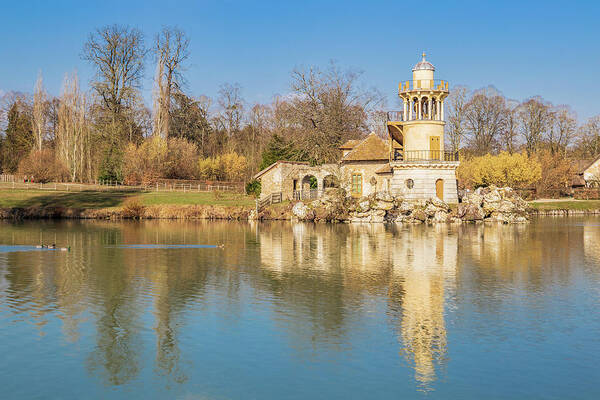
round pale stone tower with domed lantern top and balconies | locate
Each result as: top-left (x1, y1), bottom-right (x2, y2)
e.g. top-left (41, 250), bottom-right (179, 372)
top-left (387, 53), bottom-right (458, 203)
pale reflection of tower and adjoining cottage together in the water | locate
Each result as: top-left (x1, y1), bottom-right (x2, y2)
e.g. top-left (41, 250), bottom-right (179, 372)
top-left (259, 224), bottom-right (458, 388)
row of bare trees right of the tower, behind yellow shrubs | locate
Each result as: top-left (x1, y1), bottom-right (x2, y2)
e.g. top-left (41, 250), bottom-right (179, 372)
top-left (446, 86), bottom-right (600, 159)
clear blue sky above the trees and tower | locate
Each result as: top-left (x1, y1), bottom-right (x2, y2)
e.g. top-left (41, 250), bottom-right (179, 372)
top-left (0, 0), bottom-right (600, 120)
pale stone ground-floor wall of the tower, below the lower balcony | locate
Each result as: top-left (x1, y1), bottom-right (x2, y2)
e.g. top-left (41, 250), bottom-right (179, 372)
top-left (391, 164), bottom-right (458, 204)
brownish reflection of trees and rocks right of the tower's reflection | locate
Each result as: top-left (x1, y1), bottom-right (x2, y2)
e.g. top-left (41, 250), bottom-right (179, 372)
top-left (460, 219), bottom-right (582, 311)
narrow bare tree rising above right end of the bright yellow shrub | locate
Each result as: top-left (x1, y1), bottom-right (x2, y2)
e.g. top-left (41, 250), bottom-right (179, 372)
top-left (519, 97), bottom-right (550, 155)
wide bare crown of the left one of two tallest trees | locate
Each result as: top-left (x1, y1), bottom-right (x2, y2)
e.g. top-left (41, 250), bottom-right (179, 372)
top-left (82, 25), bottom-right (147, 114)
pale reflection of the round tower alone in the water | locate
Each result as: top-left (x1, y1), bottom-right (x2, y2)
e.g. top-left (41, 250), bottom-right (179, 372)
top-left (392, 226), bottom-right (458, 385)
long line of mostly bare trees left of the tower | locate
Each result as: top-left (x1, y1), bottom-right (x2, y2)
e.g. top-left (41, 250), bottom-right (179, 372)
top-left (0, 25), bottom-right (382, 182)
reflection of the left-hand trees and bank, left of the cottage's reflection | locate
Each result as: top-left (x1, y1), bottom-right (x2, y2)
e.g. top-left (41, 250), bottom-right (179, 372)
top-left (0, 221), bottom-right (253, 385)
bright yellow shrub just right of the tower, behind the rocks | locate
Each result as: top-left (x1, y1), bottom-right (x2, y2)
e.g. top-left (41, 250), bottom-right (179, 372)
top-left (457, 152), bottom-right (542, 188)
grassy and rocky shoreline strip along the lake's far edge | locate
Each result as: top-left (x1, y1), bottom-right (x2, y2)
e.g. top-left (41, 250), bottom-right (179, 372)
top-left (0, 187), bottom-right (600, 223)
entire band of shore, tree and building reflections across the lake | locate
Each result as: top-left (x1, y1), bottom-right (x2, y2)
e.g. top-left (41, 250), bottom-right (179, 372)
top-left (0, 221), bottom-right (600, 396)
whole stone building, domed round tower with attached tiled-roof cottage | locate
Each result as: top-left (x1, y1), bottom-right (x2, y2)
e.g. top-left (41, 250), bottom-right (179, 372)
top-left (254, 53), bottom-right (459, 203)
